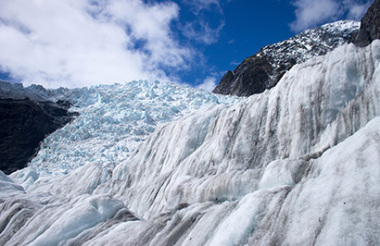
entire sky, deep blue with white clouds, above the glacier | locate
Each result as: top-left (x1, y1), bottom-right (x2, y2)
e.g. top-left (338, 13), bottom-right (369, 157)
top-left (0, 0), bottom-right (373, 90)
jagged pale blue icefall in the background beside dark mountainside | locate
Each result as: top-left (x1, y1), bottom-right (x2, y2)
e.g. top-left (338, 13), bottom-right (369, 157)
top-left (13, 80), bottom-right (241, 187)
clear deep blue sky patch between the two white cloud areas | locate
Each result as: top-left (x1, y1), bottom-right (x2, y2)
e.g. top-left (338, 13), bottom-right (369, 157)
top-left (174, 0), bottom-right (297, 89)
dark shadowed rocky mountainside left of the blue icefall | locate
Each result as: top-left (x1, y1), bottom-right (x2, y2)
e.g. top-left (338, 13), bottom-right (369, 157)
top-left (0, 82), bottom-right (76, 174)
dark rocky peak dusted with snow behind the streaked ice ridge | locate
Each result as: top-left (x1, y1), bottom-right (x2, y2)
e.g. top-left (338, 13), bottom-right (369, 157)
top-left (213, 21), bottom-right (360, 96)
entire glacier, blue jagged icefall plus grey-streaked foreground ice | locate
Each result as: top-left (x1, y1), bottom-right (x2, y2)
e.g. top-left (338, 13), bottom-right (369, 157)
top-left (0, 40), bottom-right (380, 245)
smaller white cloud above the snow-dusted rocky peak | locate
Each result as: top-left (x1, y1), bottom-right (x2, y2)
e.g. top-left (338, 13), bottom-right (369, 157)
top-left (290, 0), bottom-right (373, 32)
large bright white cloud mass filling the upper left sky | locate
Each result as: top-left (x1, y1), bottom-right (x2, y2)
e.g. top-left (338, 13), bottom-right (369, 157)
top-left (0, 0), bottom-right (191, 88)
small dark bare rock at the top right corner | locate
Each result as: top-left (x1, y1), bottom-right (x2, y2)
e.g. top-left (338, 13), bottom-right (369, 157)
top-left (354, 0), bottom-right (380, 47)
